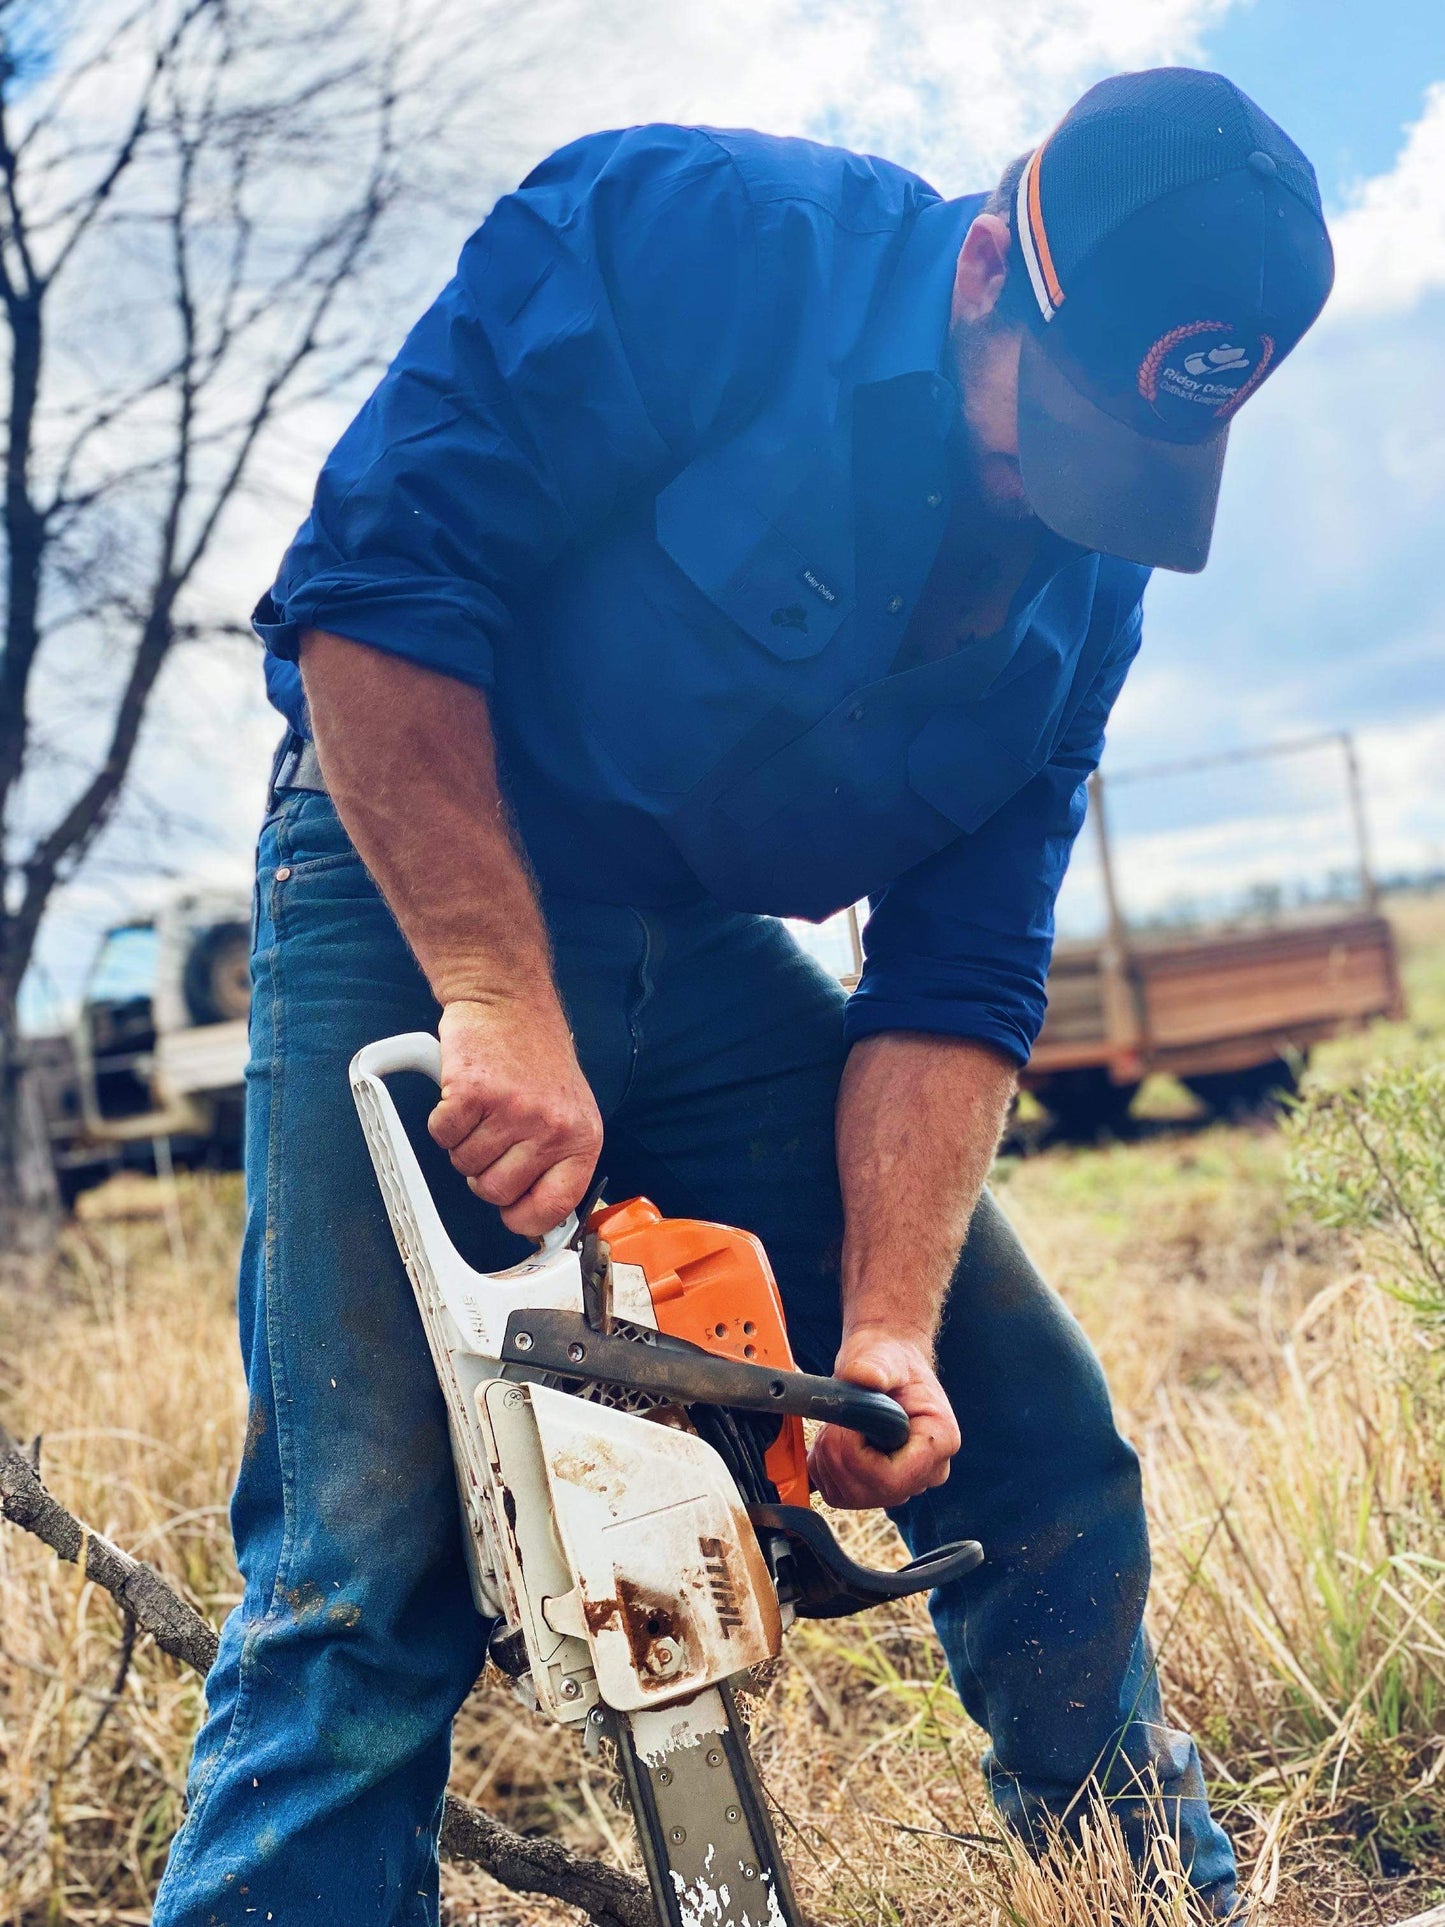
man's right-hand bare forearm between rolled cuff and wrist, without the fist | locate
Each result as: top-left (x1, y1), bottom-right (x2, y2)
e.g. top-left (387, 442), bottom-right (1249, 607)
top-left (838, 1031), bottom-right (1015, 1347)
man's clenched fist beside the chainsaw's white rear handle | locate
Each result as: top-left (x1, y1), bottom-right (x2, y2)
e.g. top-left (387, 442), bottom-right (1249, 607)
top-left (428, 998), bottom-right (603, 1237)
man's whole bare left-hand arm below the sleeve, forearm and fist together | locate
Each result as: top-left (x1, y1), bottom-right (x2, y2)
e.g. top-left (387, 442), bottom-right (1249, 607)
top-left (301, 630), bottom-right (603, 1237)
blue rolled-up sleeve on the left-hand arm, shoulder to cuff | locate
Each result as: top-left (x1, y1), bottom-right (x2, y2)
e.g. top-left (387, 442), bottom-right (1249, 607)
top-left (254, 127), bottom-right (763, 686)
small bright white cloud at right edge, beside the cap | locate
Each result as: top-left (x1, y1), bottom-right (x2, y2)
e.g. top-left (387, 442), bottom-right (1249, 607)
top-left (1326, 81), bottom-right (1445, 320)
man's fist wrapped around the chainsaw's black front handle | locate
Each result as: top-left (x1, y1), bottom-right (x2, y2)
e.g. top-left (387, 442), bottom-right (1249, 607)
top-left (807, 1326), bottom-right (963, 1507)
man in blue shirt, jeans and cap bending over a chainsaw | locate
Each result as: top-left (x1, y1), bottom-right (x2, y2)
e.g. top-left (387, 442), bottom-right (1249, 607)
top-left (156, 69), bottom-right (1331, 1927)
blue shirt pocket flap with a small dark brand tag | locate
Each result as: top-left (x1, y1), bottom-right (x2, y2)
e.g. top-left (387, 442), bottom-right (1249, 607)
top-left (657, 459), bottom-right (854, 661)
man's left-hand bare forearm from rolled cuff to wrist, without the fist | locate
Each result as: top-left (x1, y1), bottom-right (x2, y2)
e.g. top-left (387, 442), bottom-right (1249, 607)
top-left (301, 630), bottom-right (551, 1004)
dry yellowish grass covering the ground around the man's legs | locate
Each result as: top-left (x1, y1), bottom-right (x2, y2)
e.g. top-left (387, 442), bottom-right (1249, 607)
top-left (0, 906), bottom-right (1445, 1927)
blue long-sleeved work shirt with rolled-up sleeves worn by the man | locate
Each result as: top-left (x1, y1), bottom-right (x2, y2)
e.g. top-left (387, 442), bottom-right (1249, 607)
top-left (256, 125), bottom-right (1146, 1062)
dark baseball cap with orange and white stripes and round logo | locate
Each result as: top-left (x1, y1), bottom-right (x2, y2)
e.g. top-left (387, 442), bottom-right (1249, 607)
top-left (1013, 67), bottom-right (1333, 572)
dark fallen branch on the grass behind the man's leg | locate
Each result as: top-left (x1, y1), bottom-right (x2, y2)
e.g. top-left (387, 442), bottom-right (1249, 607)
top-left (0, 1426), bottom-right (657, 1927)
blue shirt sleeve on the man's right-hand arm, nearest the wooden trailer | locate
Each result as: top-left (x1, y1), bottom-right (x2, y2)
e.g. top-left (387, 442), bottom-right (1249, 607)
top-left (844, 605), bottom-right (1141, 1066)
